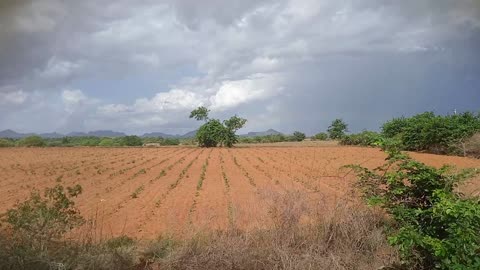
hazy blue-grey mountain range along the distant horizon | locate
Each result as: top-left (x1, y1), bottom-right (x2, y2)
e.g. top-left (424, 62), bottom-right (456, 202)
top-left (0, 129), bottom-right (282, 139)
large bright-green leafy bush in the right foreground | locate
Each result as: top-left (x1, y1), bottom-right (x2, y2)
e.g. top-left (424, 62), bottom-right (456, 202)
top-left (349, 150), bottom-right (480, 269)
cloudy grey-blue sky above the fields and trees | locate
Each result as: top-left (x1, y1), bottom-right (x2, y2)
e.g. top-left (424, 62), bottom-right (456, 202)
top-left (0, 0), bottom-right (480, 134)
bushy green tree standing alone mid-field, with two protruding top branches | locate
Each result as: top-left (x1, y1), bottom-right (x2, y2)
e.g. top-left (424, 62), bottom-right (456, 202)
top-left (190, 107), bottom-right (247, 147)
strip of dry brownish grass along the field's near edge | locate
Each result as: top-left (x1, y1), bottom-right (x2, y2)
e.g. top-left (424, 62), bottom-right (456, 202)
top-left (0, 191), bottom-right (398, 270)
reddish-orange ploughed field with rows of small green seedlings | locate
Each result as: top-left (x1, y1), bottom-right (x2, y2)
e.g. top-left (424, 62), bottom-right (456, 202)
top-left (0, 146), bottom-right (480, 238)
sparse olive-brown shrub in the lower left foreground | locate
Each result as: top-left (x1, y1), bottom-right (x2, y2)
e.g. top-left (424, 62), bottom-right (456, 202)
top-left (0, 185), bottom-right (84, 268)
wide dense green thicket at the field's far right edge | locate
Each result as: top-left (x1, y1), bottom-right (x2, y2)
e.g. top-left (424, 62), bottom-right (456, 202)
top-left (382, 112), bottom-right (480, 154)
